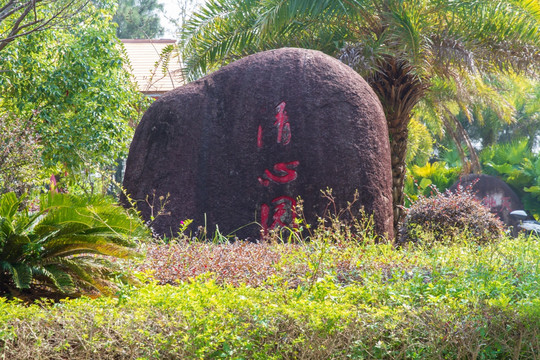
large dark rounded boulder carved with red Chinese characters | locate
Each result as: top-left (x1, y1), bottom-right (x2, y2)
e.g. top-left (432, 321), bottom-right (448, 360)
top-left (124, 48), bottom-right (393, 239)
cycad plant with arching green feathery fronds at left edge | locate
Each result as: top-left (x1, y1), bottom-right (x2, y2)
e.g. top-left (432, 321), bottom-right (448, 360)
top-left (0, 192), bottom-right (145, 298)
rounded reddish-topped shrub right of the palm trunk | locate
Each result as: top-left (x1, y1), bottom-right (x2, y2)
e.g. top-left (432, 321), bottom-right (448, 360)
top-left (398, 188), bottom-right (503, 243)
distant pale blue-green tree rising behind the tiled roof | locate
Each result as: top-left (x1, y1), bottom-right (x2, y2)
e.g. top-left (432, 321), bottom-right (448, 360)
top-left (113, 0), bottom-right (163, 39)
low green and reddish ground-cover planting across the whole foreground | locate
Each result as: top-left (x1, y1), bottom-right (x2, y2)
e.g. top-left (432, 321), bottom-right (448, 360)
top-left (0, 232), bottom-right (540, 359)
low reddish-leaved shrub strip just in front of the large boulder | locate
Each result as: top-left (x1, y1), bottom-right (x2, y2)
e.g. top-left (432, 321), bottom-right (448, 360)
top-left (135, 241), bottom-right (404, 288)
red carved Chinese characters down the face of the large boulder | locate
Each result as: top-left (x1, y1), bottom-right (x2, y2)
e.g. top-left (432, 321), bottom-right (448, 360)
top-left (257, 101), bottom-right (300, 234)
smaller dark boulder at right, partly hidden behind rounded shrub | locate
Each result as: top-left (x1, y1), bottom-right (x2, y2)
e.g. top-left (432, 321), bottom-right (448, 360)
top-left (450, 174), bottom-right (523, 235)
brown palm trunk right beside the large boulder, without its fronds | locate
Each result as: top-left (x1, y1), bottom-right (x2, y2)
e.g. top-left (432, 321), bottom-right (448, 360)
top-left (366, 57), bottom-right (427, 238)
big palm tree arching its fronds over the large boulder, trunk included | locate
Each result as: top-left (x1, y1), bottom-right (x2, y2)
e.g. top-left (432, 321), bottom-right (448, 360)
top-left (182, 0), bottom-right (540, 234)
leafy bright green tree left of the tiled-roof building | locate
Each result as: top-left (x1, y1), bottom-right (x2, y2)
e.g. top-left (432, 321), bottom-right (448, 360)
top-left (0, 0), bottom-right (146, 194)
